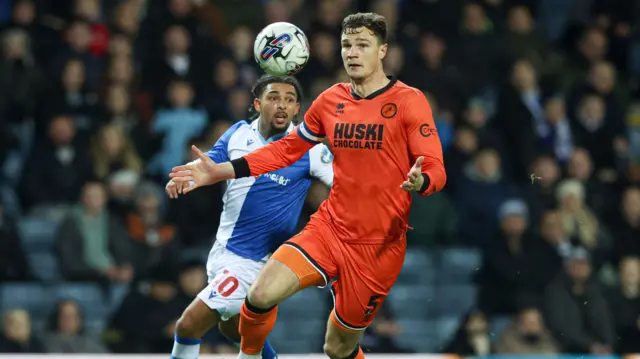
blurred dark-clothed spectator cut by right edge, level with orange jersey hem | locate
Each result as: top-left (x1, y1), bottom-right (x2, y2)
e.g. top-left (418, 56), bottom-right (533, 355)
top-left (607, 187), bottom-right (640, 265)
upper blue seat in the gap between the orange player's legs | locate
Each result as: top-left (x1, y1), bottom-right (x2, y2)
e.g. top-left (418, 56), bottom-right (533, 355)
top-left (278, 288), bottom-right (331, 318)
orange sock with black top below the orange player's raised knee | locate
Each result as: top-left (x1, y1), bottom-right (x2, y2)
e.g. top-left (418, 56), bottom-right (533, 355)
top-left (239, 300), bottom-right (278, 358)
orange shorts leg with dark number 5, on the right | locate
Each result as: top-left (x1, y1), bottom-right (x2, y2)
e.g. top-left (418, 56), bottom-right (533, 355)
top-left (331, 241), bottom-right (406, 331)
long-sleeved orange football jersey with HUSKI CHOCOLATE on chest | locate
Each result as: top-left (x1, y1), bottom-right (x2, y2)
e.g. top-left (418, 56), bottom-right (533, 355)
top-left (239, 78), bottom-right (446, 243)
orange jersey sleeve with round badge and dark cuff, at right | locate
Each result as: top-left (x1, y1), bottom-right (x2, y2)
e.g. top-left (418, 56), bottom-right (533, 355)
top-left (403, 93), bottom-right (447, 196)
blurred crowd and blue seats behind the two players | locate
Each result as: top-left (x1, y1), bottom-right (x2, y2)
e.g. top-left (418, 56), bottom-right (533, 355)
top-left (0, 0), bottom-right (640, 355)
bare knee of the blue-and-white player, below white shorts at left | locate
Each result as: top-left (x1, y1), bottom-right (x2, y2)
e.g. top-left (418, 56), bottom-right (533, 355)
top-left (176, 298), bottom-right (220, 338)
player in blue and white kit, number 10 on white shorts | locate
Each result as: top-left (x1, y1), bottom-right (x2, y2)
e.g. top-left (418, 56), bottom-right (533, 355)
top-left (166, 76), bottom-right (333, 359)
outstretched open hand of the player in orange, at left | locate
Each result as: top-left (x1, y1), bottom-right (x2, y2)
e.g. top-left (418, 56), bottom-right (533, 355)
top-left (169, 146), bottom-right (226, 194)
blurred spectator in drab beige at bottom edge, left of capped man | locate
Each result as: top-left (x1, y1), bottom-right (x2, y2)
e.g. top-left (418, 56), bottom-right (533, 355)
top-left (496, 308), bottom-right (560, 355)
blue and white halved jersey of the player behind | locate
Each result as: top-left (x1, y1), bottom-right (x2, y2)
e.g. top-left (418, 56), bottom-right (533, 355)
top-left (207, 119), bottom-right (333, 261)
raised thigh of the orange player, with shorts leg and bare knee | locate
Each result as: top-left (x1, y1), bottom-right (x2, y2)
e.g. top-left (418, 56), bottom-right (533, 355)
top-left (249, 222), bottom-right (336, 308)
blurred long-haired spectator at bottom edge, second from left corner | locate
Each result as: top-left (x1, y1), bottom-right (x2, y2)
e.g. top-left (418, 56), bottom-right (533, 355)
top-left (42, 300), bottom-right (107, 354)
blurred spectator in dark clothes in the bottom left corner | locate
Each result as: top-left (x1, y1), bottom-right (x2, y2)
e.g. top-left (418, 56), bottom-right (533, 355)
top-left (0, 309), bottom-right (45, 353)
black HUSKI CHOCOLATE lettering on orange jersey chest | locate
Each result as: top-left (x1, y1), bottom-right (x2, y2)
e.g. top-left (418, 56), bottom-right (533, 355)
top-left (332, 122), bottom-right (384, 150)
